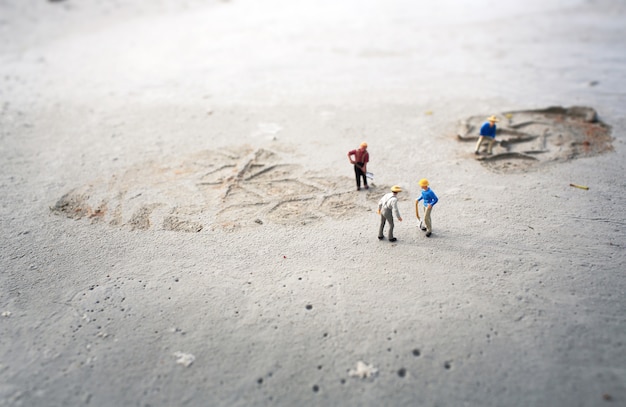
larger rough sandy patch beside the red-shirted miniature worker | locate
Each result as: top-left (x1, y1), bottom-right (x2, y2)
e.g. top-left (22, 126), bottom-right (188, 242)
top-left (52, 146), bottom-right (386, 232)
